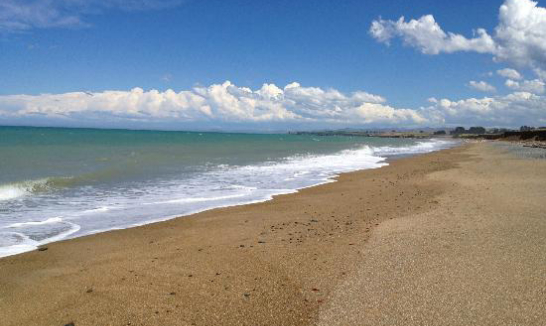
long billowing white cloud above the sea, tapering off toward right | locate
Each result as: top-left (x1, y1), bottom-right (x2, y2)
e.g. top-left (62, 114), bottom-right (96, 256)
top-left (0, 81), bottom-right (427, 128)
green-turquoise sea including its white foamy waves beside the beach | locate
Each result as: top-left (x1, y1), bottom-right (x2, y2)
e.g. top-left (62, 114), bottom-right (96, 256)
top-left (0, 127), bottom-right (454, 257)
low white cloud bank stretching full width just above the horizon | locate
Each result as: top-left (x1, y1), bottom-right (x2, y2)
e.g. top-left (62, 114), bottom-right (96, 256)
top-left (0, 81), bottom-right (546, 129)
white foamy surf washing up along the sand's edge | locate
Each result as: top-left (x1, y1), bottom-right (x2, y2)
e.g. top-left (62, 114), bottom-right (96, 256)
top-left (0, 140), bottom-right (453, 257)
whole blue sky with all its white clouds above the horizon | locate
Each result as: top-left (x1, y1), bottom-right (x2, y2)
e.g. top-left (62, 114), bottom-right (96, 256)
top-left (0, 0), bottom-right (546, 132)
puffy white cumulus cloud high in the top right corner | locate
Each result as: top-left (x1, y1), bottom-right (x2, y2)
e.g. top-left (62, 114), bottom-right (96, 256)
top-left (370, 0), bottom-right (546, 74)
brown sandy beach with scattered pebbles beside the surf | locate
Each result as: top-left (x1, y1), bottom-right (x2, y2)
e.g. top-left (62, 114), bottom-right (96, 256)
top-left (0, 143), bottom-right (546, 326)
